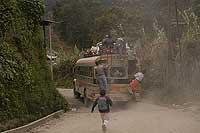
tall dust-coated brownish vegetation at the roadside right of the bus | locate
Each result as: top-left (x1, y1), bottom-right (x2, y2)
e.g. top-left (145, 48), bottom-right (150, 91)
top-left (141, 0), bottom-right (200, 104)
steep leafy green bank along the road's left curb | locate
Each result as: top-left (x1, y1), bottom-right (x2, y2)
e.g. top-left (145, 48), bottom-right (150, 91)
top-left (0, 0), bottom-right (66, 131)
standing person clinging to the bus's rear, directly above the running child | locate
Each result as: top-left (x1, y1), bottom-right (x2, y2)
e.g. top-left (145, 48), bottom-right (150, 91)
top-left (95, 62), bottom-right (108, 90)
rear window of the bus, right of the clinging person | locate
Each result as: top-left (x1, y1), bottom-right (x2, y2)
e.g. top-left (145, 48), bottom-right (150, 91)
top-left (110, 67), bottom-right (126, 77)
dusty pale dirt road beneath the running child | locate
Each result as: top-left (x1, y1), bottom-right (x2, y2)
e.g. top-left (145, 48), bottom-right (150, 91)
top-left (31, 90), bottom-right (200, 133)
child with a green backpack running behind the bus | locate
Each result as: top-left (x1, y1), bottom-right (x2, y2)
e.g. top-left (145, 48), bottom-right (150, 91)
top-left (91, 90), bottom-right (112, 130)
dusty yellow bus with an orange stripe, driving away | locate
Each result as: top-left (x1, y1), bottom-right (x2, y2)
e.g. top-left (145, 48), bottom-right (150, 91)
top-left (73, 54), bottom-right (131, 106)
